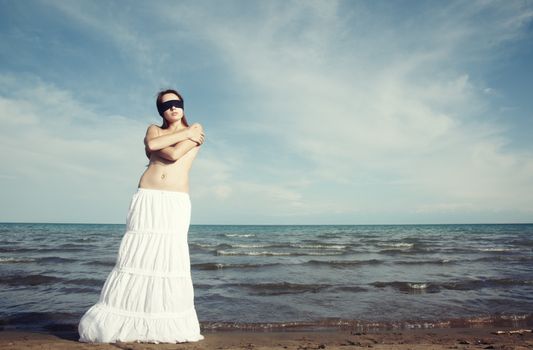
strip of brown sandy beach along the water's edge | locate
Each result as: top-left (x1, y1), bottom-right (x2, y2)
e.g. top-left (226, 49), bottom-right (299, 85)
top-left (0, 328), bottom-right (533, 350)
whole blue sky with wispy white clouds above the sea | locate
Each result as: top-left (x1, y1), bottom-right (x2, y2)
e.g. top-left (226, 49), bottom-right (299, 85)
top-left (0, 0), bottom-right (533, 224)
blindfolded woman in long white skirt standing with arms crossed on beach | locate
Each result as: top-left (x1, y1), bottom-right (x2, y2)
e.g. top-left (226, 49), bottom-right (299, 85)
top-left (78, 90), bottom-right (204, 343)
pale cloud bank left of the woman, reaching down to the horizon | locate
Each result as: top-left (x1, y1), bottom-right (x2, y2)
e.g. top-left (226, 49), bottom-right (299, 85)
top-left (0, 74), bottom-right (145, 222)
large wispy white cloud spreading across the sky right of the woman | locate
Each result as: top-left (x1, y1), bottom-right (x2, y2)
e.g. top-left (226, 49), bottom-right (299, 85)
top-left (160, 2), bottom-right (533, 217)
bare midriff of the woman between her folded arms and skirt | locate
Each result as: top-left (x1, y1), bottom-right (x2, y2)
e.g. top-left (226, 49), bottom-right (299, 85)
top-left (138, 129), bottom-right (200, 193)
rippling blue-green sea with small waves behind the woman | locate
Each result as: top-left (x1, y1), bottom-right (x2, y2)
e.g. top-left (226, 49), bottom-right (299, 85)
top-left (0, 223), bottom-right (533, 332)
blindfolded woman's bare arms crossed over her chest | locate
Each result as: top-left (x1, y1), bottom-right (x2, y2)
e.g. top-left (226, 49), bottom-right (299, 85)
top-left (144, 124), bottom-right (204, 161)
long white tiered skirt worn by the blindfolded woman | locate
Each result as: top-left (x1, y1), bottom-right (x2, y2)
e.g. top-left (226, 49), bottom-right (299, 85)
top-left (78, 188), bottom-right (204, 343)
